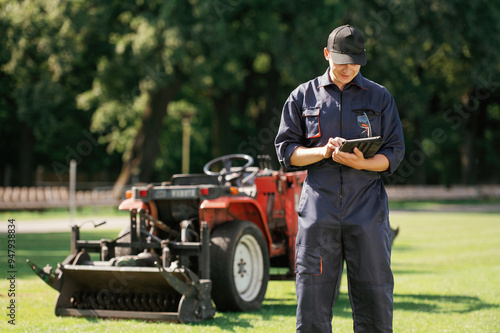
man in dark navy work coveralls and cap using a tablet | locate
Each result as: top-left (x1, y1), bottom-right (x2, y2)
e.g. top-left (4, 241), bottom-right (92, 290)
top-left (275, 25), bottom-right (404, 333)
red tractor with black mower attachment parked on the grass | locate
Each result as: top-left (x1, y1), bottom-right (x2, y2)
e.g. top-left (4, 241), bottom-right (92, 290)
top-left (28, 154), bottom-right (306, 322)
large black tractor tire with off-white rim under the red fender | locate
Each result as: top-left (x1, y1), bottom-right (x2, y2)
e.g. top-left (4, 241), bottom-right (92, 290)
top-left (210, 221), bottom-right (269, 311)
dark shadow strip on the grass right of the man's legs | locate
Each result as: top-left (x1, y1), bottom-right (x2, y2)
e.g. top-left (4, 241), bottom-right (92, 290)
top-left (394, 294), bottom-right (500, 314)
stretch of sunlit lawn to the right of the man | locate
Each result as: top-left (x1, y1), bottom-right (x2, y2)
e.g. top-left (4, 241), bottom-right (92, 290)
top-left (392, 213), bottom-right (500, 333)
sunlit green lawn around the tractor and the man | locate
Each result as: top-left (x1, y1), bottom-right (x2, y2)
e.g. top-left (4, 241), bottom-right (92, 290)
top-left (0, 208), bottom-right (500, 333)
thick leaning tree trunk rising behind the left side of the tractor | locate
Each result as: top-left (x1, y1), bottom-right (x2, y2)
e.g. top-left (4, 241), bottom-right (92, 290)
top-left (113, 84), bottom-right (180, 197)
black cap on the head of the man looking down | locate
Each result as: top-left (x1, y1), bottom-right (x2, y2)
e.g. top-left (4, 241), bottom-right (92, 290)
top-left (327, 24), bottom-right (366, 65)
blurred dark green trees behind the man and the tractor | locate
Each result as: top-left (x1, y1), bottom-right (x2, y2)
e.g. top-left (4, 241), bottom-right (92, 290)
top-left (0, 0), bottom-right (500, 204)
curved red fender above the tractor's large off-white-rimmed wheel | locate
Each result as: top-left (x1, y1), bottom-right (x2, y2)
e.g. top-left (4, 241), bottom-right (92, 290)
top-left (200, 196), bottom-right (272, 249)
